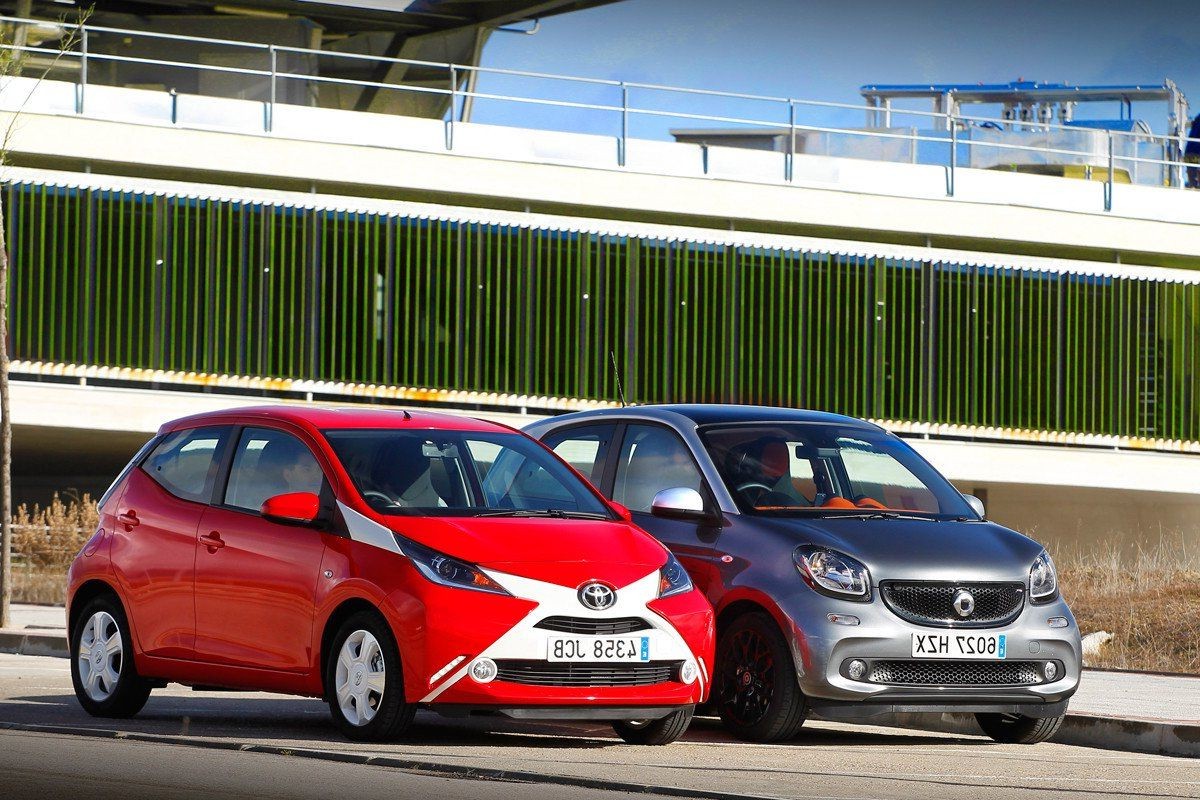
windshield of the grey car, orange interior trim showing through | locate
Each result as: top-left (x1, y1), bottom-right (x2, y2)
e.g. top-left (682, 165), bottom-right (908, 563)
top-left (700, 422), bottom-right (976, 519)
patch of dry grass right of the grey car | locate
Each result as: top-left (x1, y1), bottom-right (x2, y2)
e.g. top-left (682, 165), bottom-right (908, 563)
top-left (1054, 537), bottom-right (1200, 674)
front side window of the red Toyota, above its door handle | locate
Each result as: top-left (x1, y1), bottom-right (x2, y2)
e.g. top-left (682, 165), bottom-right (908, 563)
top-left (224, 428), bottom-right (325, 513)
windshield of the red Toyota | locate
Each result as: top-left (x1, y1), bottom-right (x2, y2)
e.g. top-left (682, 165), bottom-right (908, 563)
top-left (324, 429), bottom-right (613, 519)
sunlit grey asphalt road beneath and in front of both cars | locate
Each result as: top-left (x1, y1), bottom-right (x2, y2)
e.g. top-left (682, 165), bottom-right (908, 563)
top-left (0, 655), bottom-right (1200, 800)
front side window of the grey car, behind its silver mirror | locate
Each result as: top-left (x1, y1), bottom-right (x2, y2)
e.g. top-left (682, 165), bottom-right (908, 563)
top-left (612, 425), bottom-right (701, 513)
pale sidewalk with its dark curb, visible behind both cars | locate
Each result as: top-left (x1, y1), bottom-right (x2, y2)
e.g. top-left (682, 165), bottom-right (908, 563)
top-left (7, 604), bottom-right (1200, 757)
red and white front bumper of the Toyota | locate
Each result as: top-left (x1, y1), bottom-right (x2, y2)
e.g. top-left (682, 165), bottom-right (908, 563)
top-left (390, 563), bottom-right (714, 720)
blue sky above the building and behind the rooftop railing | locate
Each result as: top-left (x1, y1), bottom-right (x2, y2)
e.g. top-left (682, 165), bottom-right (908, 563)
top-left (474, 0), bottom-right (1200, 138)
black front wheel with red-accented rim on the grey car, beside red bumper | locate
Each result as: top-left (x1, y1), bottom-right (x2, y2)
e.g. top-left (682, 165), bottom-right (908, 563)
top-left (714, 612), bottom-right (808, 742)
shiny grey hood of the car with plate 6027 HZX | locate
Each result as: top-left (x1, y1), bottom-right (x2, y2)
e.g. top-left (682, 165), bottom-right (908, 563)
top-left (761, 517), bottom-right (1043, 585)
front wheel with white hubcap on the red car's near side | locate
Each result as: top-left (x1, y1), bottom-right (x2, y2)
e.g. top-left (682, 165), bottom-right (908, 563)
top-left (325, 612), bottom-right (416, 741)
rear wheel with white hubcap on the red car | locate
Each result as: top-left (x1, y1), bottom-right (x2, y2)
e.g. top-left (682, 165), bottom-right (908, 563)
top-left (71, 595), bottom-right (150, 718)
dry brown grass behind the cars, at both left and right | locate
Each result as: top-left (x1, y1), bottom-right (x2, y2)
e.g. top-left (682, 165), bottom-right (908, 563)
top-left (4, 495), bottom-right (1200, 673)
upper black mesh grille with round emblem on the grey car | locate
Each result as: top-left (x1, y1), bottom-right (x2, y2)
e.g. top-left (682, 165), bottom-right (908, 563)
top-left (881, 581), bottom-right (1025, 627)
